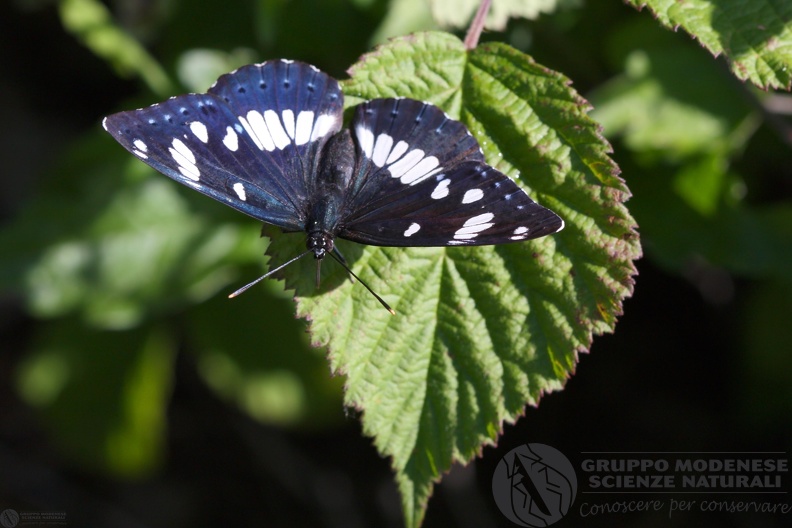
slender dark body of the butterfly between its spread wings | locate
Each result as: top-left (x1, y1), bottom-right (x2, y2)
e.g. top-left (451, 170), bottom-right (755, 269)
top-left (305, 130), bottom-right (355, 259)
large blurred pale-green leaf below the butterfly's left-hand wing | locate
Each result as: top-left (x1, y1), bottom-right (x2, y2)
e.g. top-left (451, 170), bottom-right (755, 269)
top-left (0, 130), bottom-right (261, 329)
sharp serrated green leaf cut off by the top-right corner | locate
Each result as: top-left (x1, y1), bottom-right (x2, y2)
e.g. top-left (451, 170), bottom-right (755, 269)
top-left (628, 0), bottom-right (792, 90)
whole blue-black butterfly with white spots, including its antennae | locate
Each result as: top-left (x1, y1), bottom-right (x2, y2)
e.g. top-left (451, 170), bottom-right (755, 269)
top-left (102, 59), bottom-right (564, 313)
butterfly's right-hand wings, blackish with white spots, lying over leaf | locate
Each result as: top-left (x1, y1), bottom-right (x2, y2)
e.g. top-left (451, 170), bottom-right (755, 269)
top-left (338, 99), bottom-right (564, 246)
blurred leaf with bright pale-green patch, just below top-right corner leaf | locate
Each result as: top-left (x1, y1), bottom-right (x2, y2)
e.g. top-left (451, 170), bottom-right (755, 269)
top-left (591, 19), bottom-right (757, 161)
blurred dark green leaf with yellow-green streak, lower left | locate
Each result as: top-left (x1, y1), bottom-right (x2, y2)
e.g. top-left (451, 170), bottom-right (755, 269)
top-left (17, 319), bottom-right (174, 477)
